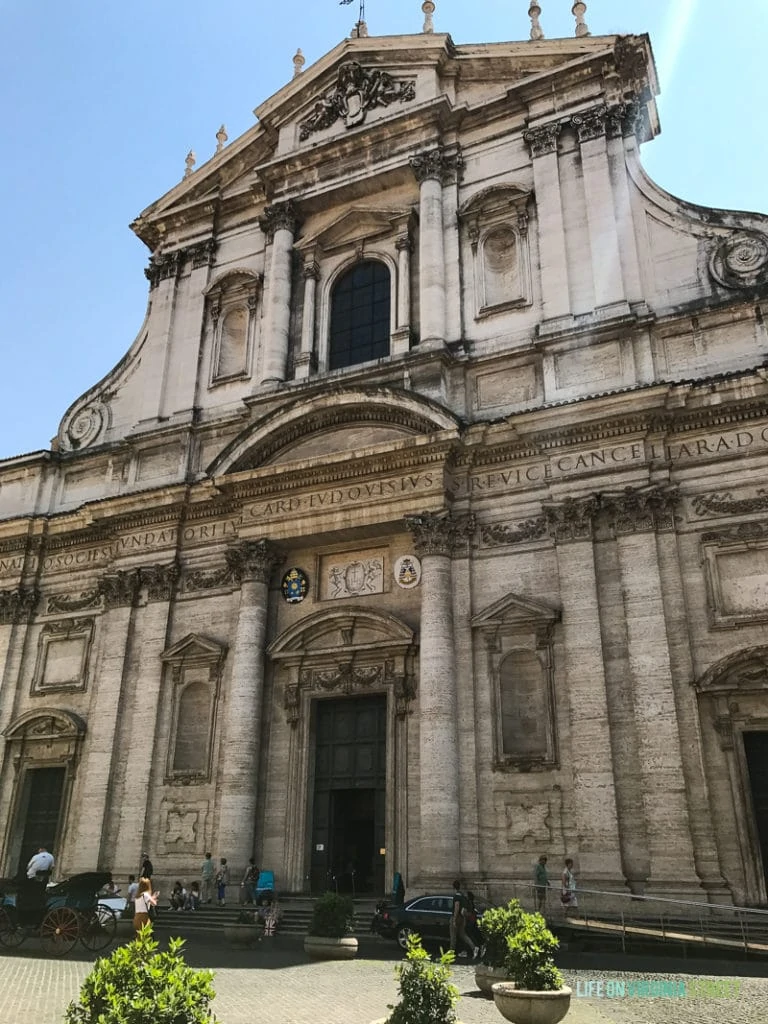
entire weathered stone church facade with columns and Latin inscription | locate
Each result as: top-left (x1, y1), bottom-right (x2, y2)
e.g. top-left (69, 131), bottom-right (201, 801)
top-left (0, 16), bottom-right (768, 903)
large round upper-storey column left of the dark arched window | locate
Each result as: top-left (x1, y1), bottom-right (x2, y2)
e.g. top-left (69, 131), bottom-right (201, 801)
top-left (260, 202), bottom-right (297, 384)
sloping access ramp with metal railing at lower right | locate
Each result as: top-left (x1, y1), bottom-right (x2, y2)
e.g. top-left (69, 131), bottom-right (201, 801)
top-left (510, 882), bottom-right (768, 955)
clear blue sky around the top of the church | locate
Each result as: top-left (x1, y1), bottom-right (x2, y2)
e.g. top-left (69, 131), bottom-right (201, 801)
top-left (0, 0), bottom-right (768, 458)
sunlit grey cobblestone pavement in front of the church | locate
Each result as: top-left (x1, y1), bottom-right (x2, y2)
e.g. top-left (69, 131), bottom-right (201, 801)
top-left (0, 938), bottom-right (768, 1024)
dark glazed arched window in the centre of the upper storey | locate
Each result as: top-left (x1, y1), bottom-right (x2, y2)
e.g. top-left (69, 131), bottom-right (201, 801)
top-left (328, 260), bottom-right (391, 370)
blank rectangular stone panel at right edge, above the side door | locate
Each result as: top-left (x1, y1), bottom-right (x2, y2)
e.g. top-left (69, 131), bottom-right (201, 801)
top-left (705, 541), bottom-right (768, 629)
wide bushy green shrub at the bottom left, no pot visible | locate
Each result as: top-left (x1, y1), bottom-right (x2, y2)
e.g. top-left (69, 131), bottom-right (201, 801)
top-left (65, 926), bottom-right (216, 1024)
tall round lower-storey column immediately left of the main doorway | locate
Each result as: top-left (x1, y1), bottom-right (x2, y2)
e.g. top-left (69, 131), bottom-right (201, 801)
top-left (218, 541), bottom-right (279, 873)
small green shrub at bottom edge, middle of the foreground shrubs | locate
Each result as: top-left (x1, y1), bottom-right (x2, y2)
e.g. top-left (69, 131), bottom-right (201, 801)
top-left (387, 935), bottom-right (459, 1024)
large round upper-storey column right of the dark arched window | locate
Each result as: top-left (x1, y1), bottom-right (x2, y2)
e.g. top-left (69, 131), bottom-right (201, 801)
top-left (411, 147), bottom-right (457, 345)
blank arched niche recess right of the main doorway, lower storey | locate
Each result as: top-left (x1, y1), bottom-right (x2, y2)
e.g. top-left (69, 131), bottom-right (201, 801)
top-left (499, 650), bottom-right (550, 758)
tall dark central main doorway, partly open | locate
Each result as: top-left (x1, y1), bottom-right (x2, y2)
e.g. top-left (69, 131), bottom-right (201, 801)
top-left (310, 694), bottom-right (387, 895)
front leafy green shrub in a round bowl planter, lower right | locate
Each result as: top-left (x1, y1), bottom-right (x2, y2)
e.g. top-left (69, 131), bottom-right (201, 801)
top-left (493, 911), bottom-right (570, 1024)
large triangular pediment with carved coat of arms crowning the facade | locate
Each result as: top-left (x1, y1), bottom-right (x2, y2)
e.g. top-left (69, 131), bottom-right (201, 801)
top-left (132, 33), bottom-right (655, 248)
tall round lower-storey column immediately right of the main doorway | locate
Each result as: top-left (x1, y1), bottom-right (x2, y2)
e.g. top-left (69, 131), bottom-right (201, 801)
top-left (406, 512), bottom-right (472, 885)
